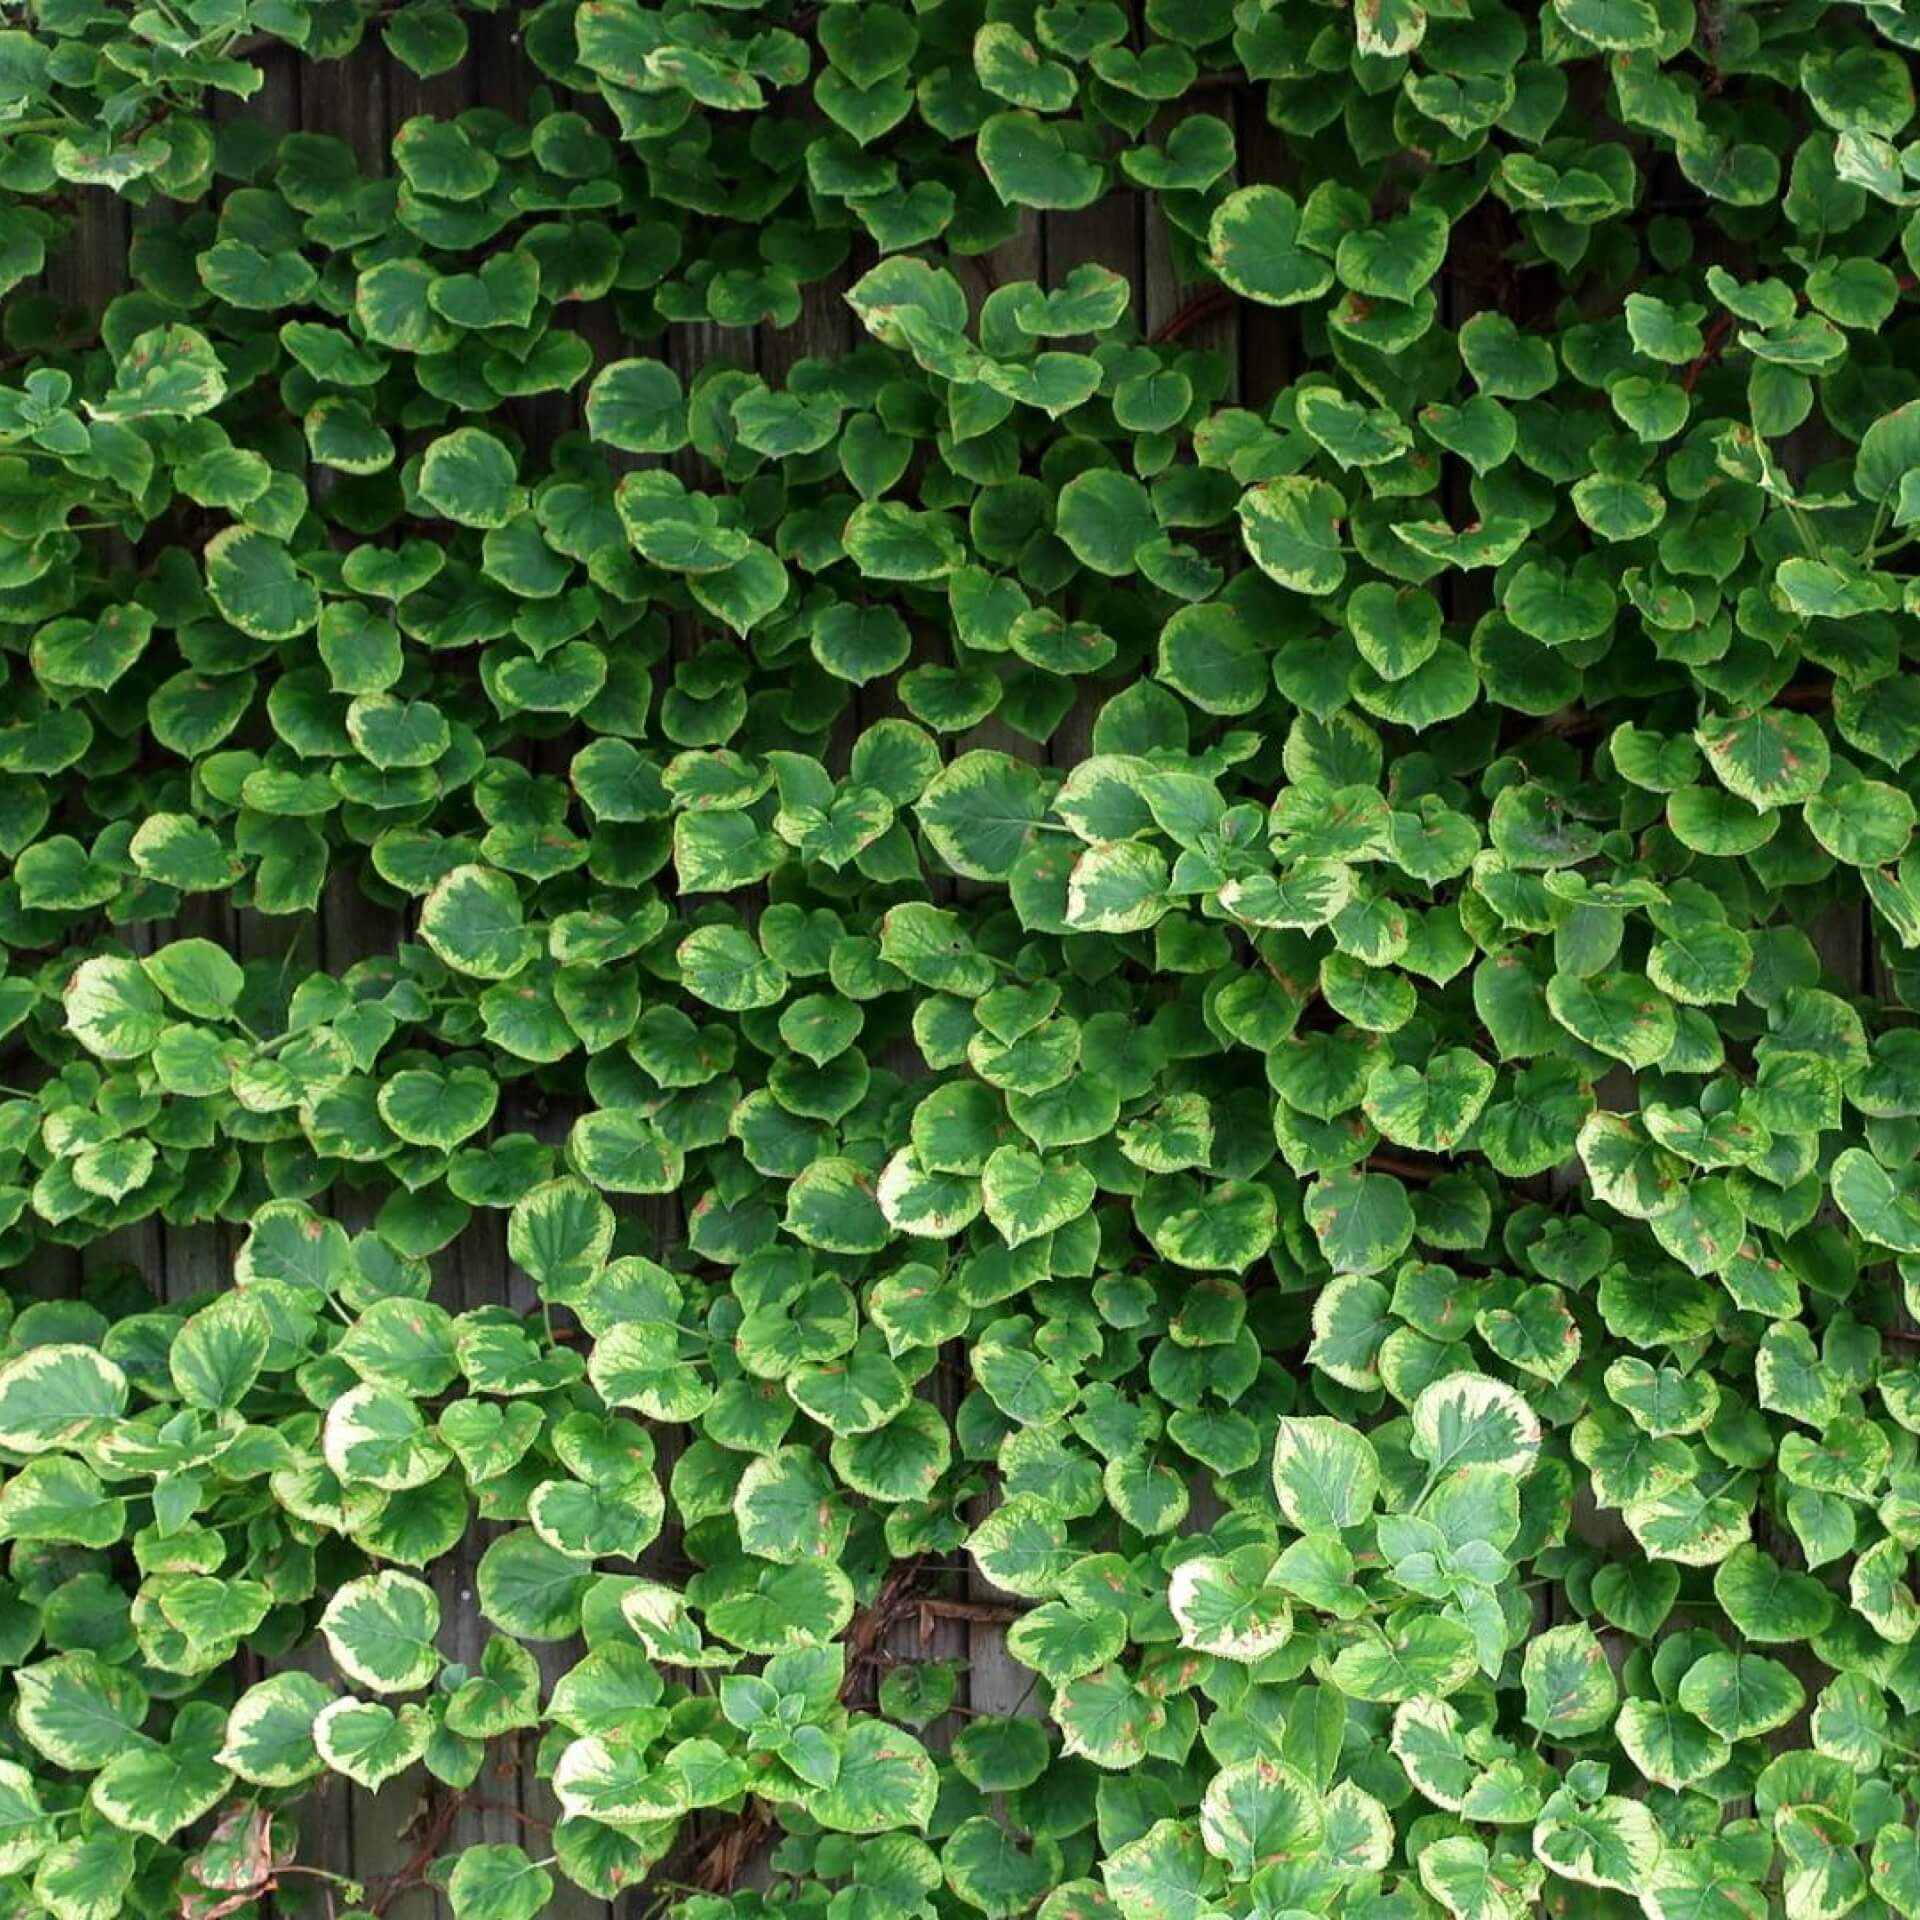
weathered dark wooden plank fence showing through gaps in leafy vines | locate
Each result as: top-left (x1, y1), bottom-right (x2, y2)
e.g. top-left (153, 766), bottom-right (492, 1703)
top-left (15, 8), bottom-right (1874, 1920)
